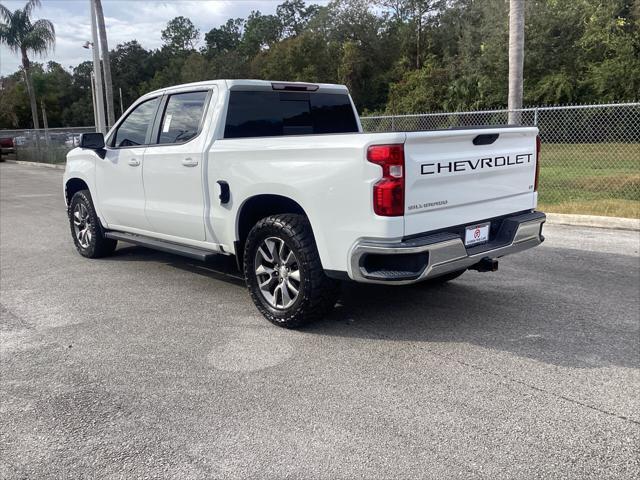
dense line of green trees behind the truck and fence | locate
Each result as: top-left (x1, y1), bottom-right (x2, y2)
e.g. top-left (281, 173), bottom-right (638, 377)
top-left (0, 0), bottom-right (640, 128)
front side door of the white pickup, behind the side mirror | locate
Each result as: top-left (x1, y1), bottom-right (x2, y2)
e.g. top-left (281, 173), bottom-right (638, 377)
top-left (96, 97), bottom-right (161, 230)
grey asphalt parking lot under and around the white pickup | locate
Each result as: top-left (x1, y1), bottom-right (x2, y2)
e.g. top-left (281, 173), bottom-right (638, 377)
top-left (0, 164), bottom-right (640, 479)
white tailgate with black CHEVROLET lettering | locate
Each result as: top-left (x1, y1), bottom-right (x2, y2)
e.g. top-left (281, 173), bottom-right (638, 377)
top-left (404, 127), bottom-right (538, 236)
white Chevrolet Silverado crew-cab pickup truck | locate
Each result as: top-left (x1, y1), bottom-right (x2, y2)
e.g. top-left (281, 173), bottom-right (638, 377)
top-left (64, 80), bottom-right (545, 327)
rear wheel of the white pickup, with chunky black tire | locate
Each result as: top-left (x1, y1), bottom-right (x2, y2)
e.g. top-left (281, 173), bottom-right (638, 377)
top-left (244, 214), bottom-right (339, 328)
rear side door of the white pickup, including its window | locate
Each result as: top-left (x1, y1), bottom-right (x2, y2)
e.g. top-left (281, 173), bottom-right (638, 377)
top-left (142, 90), bottom-right (211, 241)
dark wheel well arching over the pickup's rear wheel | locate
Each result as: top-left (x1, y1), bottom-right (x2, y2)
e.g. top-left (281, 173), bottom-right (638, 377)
top-left (235, 195), bottom-right (307, 267)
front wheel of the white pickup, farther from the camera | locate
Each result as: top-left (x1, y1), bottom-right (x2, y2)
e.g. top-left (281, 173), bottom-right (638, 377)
top-left (68, 190), bottom-right (118, 258)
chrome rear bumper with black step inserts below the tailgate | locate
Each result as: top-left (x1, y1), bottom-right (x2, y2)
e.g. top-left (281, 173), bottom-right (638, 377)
top-left (349, 212), bottom-right (546, 285)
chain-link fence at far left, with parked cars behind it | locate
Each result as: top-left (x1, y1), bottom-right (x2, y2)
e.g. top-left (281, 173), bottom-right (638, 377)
top-left (0, 127), bottom-right (96, 163)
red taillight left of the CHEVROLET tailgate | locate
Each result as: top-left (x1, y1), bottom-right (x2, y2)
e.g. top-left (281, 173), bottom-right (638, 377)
top-left (367, 144), bottom-right (404, 217)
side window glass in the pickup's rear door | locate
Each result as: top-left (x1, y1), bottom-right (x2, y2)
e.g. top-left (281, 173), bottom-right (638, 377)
top-left (158, 91), bottom-right (208, 143)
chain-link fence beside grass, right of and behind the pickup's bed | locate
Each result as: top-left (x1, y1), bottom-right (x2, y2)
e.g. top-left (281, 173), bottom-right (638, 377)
top-left (360, 103), bottom-right (640, 218)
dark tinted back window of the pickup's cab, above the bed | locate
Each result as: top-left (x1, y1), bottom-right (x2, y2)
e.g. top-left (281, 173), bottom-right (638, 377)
top-left (224, 91), bottom-right (358, 138)
